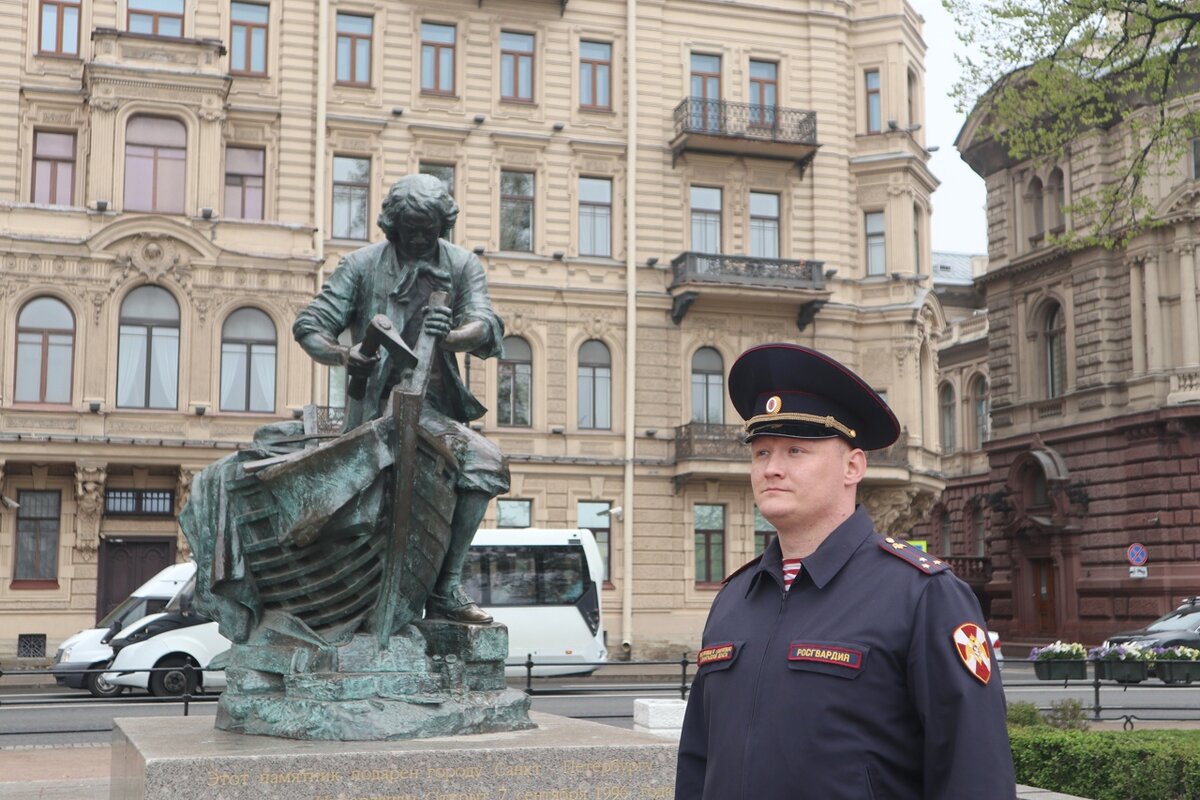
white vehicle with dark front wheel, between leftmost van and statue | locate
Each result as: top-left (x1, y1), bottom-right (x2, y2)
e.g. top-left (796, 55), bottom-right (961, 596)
top-left (104, 578), bottom-right (232, 697)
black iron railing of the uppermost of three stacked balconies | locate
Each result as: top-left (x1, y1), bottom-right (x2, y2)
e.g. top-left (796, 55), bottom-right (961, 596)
top-left (674, 97), bottom-right (817, 148)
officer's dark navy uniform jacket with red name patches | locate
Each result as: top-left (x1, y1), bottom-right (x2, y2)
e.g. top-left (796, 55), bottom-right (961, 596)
top-left (676, 506), bottom-right (1016, 800)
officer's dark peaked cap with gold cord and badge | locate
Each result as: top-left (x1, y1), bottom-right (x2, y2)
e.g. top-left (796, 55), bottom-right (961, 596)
top-left (730, 343), bottom-right (900, 450)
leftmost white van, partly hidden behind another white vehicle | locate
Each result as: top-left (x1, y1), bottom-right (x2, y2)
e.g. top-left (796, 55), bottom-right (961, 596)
top-left (52, 561), bottom-right (196, 697)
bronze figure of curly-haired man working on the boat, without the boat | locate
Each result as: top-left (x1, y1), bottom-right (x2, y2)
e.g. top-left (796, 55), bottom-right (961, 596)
top-left (300, 175), bottom-right (509, 625)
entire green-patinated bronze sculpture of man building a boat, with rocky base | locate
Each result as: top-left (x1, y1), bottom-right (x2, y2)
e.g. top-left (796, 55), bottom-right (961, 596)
top-left (180, 175), bottom-right (533, 740)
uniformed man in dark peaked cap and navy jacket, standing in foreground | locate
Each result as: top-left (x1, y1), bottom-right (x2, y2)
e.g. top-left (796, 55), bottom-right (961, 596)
top-left (676, 344), bottom-right (1016, 800)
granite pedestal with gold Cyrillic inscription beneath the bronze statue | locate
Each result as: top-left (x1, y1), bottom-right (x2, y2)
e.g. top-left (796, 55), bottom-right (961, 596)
top-left (110, 714), bottom-right (677, 800)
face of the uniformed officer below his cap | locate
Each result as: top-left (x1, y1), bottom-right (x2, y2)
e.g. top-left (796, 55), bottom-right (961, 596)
top-left (750, 437), bottom-right (860, 528)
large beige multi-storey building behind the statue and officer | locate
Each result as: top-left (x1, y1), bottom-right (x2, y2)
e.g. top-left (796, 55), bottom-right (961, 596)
top-left (0, 0), bottom-right (947, 658)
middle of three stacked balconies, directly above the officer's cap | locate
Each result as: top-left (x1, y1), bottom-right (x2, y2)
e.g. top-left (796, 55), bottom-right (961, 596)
top-left (671, 252), bottom-right (829, 330)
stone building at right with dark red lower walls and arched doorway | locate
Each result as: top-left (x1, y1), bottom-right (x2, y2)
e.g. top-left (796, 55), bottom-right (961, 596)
top-left (958, 97), bottom-right (1200, 642)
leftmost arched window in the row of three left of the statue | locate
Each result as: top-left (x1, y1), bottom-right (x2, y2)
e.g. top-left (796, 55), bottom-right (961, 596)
top-left (13, 297), bottom-right (74, 403)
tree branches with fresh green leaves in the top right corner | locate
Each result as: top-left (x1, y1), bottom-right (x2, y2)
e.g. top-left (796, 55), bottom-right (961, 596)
top-left (943, 0), bottom-right (1200, 247)
